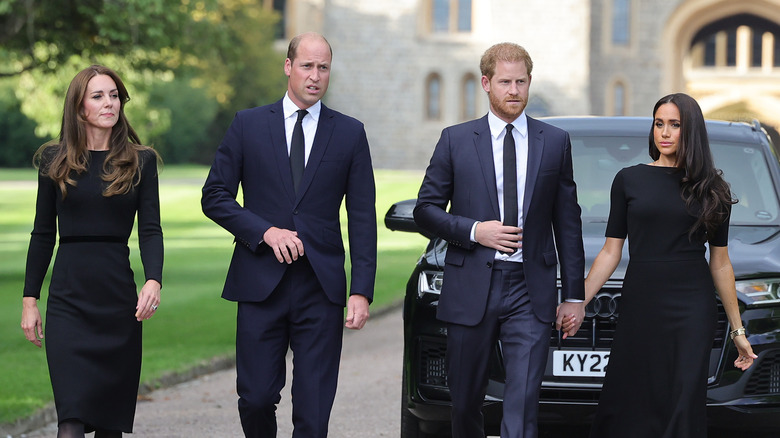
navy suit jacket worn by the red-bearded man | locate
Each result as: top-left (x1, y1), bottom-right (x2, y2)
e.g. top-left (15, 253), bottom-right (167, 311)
top-left (414, 116), bottom-right (585, 325)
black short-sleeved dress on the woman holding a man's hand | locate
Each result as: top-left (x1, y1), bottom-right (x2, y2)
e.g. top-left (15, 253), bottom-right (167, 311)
top-left (591, 164), bottom-right (728, 438)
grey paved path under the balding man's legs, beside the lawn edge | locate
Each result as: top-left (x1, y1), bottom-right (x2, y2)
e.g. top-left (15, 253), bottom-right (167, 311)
top-left (21, 309), bottom-right (403, 438)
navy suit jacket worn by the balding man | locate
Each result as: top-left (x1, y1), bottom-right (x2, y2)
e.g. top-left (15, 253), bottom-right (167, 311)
top-left (201, 100), bottom-right (376, 306)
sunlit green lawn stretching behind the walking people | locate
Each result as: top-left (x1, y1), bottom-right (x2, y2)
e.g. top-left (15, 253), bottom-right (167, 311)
top-left (0, 166), bottom-right (425, 424)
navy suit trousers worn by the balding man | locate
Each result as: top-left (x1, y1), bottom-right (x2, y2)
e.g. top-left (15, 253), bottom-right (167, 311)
top-left (236, 257), bottom-right (344, 438)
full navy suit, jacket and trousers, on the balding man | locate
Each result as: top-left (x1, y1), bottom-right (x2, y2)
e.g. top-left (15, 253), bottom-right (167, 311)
top-left (202, 100), bottom-right (376, 436)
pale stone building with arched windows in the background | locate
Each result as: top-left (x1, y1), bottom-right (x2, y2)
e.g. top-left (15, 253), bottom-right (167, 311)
top-left (263, 0), bottom-right (780, 169)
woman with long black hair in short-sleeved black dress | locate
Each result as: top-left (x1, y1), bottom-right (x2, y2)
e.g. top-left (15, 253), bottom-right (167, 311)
top-left (564, 93), bottom-right (757, 438)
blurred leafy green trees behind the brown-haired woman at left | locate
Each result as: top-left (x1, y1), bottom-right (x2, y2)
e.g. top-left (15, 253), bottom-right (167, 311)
top-left (0, 0), bottom-right (285, 162)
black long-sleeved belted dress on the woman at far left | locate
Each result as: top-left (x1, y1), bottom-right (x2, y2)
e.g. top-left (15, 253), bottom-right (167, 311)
top-left (24, 150), bottom-right (163, 432)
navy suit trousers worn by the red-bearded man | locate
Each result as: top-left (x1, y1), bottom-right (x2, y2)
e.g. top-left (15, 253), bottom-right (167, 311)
top-left (447, 262), bottom-right (550, 438)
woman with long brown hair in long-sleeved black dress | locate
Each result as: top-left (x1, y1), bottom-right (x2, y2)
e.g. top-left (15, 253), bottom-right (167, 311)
top-left (22, 65), bottom-right (163, 438)
